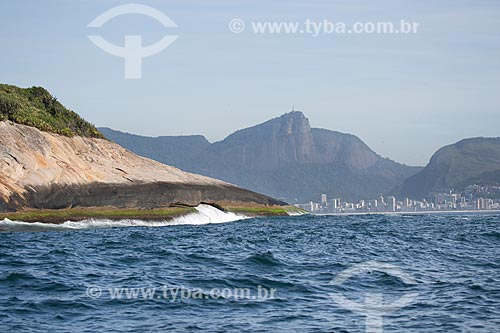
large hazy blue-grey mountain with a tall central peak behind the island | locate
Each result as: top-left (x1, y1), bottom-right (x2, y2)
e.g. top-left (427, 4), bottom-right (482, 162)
top-left (100, 111), bottom-right (421, 202)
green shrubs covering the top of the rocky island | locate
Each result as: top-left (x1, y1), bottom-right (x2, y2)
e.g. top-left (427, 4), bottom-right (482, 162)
top-left (0, 84), bottom-right (104, 138)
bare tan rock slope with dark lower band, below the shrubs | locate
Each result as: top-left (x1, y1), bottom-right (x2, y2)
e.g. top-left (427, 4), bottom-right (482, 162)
top-left (0, 121), bottom-right (283, 211)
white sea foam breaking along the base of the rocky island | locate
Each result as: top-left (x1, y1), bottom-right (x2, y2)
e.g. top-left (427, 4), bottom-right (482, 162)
top-left (0, 205), bottom-right (248, 231)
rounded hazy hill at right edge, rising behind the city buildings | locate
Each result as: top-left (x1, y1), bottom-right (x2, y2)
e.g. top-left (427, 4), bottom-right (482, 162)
top-left (399, 138), bottom-right (500, 198)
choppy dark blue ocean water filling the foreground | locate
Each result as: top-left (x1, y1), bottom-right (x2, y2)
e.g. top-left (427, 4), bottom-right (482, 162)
top-left (0, 207), bottom-right (500, 332)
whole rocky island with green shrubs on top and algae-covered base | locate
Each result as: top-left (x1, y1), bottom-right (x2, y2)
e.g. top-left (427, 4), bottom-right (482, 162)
top-left (0, 85), bottom-right (291, 222)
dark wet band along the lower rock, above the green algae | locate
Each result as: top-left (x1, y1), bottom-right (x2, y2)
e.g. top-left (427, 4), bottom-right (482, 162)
top-left (0, 182), bottom-right (286, 212)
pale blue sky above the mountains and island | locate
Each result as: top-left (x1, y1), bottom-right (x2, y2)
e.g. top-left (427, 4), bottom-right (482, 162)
top-left (0, 0), bottom-right (500, 165)
